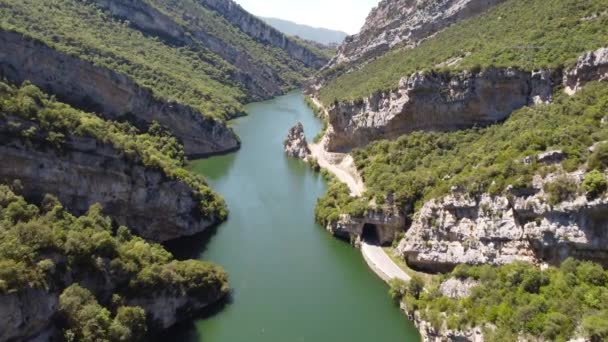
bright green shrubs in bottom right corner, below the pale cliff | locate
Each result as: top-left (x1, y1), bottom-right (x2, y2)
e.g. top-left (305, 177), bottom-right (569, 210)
top-left (390, 259), bottom-right (608, 341)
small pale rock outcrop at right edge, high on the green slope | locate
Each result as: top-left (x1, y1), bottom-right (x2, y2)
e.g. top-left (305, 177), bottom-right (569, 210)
top-left (564, 48), bottom-right (608, 94)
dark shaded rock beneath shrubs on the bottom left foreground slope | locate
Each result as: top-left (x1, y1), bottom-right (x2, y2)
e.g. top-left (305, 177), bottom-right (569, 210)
top-left (0, 256), bottom-right (226, 342)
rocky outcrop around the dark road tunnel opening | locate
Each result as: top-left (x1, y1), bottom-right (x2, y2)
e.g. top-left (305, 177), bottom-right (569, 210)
top-left (326, 209), bottom-right (405, 245)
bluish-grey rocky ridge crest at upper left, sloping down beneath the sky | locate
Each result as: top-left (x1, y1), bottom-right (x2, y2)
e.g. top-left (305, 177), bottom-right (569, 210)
top-left (200, 0), bottom-right (327, 69)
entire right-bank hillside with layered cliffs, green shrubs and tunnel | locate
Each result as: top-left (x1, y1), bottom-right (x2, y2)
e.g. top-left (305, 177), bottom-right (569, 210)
top-left (310, 0), bottom-right (608, 341)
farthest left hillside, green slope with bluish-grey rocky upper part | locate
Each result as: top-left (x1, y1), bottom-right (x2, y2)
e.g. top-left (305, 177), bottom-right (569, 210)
top-left (0, 0), bottom-right (326, 119)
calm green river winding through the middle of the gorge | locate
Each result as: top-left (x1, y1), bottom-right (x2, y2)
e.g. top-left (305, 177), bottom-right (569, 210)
top-left (166, 92), bottom-right (420, 342)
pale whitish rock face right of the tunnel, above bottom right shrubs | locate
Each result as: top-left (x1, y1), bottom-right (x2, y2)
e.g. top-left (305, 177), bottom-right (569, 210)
top-left (398, 172), bottom-right (608, 272)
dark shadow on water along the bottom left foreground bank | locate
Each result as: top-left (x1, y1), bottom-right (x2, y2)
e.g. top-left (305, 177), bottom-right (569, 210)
top-left (150, 290), bottom-right (234, 342)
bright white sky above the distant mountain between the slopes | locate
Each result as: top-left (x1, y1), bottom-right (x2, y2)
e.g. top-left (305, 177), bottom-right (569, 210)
top-left (235, 0), bottom-right (380, 34)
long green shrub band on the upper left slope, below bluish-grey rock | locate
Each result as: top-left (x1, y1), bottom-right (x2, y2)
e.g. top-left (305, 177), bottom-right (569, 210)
top-left (0, 0), bottom-right (245, 118)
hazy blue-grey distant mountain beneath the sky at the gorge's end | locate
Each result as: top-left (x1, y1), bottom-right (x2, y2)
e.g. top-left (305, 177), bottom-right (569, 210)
top-left (261, 18), bottom-right (348, 45)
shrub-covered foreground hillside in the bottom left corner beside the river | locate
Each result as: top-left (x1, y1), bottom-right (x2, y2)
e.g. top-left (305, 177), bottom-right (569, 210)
top-left (0, 185), bottom-right (229, 341)
